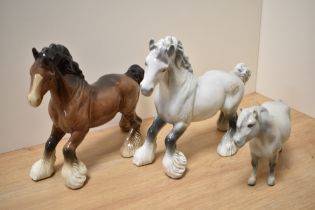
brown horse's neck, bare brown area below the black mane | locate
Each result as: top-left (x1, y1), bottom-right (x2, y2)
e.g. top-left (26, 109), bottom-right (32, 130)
top-left (50, 74), bottom-right (88, 106)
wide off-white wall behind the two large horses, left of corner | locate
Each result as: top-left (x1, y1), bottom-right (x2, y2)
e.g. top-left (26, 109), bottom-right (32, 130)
top-left (0, 0), bottom-right (261, 152)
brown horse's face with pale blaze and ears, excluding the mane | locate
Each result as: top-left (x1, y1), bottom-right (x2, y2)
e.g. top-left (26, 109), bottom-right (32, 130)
top-left (27, 48), bottom-right (56, 107)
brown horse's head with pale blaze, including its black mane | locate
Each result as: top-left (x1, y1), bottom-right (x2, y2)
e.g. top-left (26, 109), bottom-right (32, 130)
top-left (28, 44), bottom-right (84, 107)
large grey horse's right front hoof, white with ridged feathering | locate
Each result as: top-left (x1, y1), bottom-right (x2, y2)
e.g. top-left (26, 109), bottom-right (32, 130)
top-left (163, 150), bottom-right (187, 179)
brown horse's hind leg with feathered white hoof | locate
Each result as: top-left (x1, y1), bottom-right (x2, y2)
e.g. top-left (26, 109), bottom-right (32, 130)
top-left (120, 112), bottom-right (143, 157)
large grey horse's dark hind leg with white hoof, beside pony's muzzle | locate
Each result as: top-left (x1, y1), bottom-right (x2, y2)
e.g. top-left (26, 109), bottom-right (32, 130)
top-left (217, 112), bottom-right (238, 157)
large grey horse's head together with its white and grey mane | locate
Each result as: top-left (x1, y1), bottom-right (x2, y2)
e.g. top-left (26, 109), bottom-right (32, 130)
top-left (141, 36), bottom-right (192, 96)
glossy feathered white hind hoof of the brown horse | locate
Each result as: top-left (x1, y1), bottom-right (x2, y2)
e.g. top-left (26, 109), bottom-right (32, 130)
top-left (120, 129), bottom-right (143, 158)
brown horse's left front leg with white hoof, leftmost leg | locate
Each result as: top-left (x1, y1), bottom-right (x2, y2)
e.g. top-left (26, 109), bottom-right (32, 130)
top-left (30, 125), bottom-right (65, 181)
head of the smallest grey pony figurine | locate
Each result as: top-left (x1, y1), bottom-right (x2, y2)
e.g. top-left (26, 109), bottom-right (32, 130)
top-left (233, 106), bottom-right (268, 148)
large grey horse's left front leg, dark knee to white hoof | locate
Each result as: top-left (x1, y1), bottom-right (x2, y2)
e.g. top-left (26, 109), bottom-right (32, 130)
top-left (133, 117), bottom-right (166, 166)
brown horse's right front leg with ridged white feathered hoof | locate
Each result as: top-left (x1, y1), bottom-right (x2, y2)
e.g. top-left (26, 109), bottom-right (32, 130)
top-left (61, 131), bottom-right (88, 189)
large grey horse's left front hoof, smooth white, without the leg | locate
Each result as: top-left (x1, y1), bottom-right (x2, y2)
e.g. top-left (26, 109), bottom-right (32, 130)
top-left (132, 141), bottom-right (156, 166)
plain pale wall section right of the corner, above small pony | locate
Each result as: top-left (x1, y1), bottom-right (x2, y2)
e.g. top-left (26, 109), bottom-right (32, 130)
top-left (257, 0), bottom-right (315, 118)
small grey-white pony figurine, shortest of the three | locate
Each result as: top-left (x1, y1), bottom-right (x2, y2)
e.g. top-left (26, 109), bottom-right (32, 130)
top-left (233, 101), bottom-right (291, 186)
